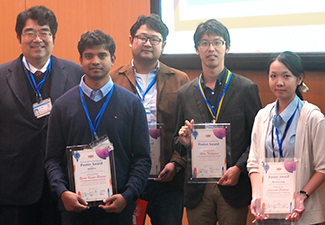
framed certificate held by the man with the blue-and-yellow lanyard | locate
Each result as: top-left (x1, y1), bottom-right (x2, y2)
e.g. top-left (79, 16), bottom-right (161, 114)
top-left (188, 123), bottom-right (230, 183)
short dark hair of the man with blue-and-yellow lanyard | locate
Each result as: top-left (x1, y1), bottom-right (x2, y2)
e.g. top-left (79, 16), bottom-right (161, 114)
top-left (194, 19), bottom-right (230, 49)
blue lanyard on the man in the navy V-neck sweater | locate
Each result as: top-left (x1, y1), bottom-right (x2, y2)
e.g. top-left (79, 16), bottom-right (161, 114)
top-left (79, 85), bottom-right (114, 140)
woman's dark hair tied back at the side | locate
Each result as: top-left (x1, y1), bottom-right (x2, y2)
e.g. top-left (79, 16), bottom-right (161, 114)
top-left (267, 51), bottom-right (305, 100)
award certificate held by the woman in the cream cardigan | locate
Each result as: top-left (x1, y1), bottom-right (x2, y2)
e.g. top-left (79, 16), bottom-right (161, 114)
top-left (261, 160), bottom-right (296, 217)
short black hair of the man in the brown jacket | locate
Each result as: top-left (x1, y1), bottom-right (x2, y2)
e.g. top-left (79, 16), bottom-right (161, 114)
top-left (130, 13), bottom-right (169, 41)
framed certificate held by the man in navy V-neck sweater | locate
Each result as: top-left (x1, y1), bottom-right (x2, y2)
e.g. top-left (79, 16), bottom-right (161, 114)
top-left (66, 145), bottom-right (117, 206)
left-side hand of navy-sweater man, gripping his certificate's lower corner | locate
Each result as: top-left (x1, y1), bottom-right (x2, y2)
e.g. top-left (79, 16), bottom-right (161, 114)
top-left (61, 191), bottom-right (89, 212)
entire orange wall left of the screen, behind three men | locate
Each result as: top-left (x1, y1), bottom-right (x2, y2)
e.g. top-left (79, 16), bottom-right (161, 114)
top-left (0, 0), bottom-right (150, 67)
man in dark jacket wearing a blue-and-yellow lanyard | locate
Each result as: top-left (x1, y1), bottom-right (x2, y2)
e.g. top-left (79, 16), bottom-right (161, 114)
top-left (173, 19), bottom-right (261, 225)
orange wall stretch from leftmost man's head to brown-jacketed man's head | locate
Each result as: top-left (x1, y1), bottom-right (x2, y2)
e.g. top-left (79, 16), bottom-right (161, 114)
top-left (27, 0), bottom-right (150, 66)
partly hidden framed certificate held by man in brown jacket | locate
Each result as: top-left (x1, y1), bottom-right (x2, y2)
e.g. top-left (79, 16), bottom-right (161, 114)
top-left (148, 123), bottom-right (164, 179)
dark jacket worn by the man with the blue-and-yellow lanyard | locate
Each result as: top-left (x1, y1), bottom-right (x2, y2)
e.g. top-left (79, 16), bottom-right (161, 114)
top-left (174, 71), bottom-right (261, 208)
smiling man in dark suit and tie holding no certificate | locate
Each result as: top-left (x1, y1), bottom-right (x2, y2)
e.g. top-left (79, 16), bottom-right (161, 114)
top-left (0, 6), bottom-right (83, 225)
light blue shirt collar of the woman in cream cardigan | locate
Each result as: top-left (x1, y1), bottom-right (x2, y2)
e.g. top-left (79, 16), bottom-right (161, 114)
top-left (271, 95), bottom-right (299, 129)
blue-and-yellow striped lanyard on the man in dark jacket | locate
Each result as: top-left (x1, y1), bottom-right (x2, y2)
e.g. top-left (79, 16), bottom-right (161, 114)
top-left (197, 70), bottom-right (232, 123)
